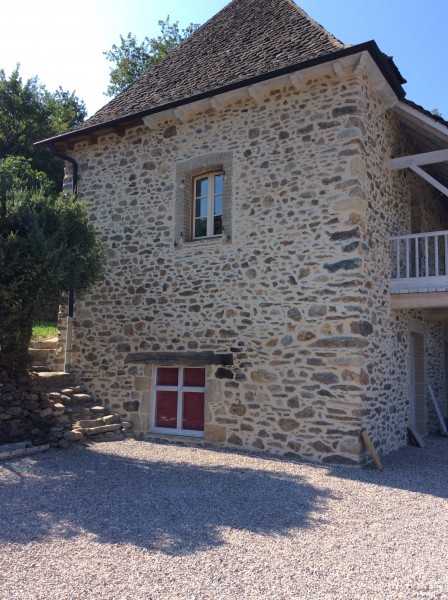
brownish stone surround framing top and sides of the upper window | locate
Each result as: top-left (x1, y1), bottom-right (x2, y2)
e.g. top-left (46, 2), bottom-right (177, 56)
top-left (174, 152), bottom-right (233, 242)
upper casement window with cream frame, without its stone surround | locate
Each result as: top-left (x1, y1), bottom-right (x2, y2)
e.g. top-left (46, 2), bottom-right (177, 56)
top-left (193, 173), bottom-right (224, 239)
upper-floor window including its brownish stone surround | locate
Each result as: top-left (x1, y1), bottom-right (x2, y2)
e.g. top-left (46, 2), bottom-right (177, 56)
top-left (173, 152), bottom-right (233, 247)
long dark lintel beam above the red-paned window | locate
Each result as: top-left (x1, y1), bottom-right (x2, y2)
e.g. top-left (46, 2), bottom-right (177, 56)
top-left (124, 351), bottom-right (233, 367)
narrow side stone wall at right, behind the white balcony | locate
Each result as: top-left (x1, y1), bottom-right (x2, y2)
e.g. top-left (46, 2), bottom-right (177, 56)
top-left (350, 75), bottom-right (448, 453)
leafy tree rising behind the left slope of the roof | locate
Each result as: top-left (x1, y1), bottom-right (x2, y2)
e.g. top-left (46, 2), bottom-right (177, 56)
top-left (104, 15), bottom-right (199, 97)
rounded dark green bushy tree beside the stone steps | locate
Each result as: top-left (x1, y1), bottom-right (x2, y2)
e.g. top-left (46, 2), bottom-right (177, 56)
top-left (0, 188), bottom-right (105, 373)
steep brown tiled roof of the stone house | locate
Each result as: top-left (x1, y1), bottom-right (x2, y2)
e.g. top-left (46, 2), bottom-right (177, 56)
top-left (69, 0), bottom-right (347, 130)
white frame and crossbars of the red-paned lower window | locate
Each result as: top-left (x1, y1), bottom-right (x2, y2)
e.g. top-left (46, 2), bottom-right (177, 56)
top-left (151, 365), bottom-right (207, 438)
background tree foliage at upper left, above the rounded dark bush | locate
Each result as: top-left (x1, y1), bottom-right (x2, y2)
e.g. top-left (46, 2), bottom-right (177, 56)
top-left (0, 66), bottom-right (87, 189)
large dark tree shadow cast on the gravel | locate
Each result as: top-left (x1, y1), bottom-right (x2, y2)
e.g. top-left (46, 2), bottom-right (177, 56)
top-left (0, 449), bottom-right (331, 555)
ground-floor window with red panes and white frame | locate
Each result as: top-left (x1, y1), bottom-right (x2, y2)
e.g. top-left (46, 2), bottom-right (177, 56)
top-left (152, 367), bottom-right (205, 437)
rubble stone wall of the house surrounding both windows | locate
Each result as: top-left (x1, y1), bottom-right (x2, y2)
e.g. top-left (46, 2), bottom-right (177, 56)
top-left (61, 73), bottom-right (446, 464)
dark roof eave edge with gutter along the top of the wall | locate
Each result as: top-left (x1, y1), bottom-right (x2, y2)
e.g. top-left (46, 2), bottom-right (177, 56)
top-left (35, 40), bottom-right (405, 146)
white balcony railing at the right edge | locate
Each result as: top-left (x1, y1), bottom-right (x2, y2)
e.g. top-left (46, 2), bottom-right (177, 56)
top-left (391, 231), bottom-right (448, 293)
